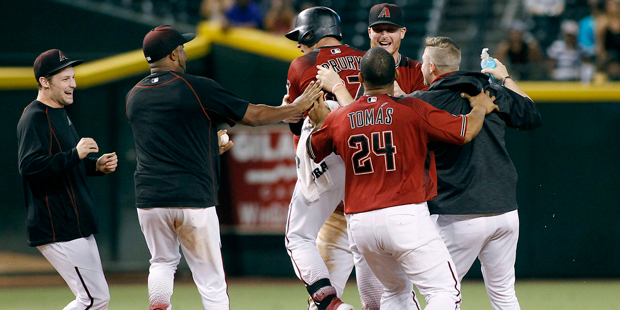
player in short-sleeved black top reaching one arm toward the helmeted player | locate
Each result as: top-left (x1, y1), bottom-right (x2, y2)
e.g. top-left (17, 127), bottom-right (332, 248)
top-left (127, 25), bottom-right (322, 310)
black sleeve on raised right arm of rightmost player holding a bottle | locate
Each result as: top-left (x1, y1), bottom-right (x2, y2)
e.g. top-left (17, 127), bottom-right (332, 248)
top-left (489, 84), bottom-right (542, 130)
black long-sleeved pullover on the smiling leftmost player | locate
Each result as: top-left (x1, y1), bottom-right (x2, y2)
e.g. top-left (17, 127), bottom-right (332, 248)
top-left (17, 100), bottom-right (103, 246)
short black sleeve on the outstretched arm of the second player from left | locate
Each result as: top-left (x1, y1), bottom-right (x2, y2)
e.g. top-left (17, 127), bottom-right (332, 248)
top-left (198, 78), bottom-right (250, 127)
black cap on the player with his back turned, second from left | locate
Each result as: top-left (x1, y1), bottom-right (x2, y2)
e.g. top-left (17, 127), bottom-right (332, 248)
top-left (142, 25), bottom-right (196, 63)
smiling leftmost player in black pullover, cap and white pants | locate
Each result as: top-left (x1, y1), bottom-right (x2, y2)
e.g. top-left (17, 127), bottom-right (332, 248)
top-left (17, 49), bottom-right (118, 310)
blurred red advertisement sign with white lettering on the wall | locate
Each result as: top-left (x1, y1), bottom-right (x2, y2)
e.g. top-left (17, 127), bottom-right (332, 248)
top-left (227, 125), bottom-right (297, 233)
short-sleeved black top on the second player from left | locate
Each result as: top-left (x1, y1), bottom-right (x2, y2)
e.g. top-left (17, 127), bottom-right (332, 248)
top-left (127, 71), bottom-right (249, 208)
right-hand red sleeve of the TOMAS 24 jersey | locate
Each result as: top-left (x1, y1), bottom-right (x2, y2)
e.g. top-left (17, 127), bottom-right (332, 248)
top-left (413, 99), bottom-right (467, 145)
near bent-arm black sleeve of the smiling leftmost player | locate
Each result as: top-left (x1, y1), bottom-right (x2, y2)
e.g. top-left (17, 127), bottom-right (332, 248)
top-left (17, 119), bottom-right (81, 180)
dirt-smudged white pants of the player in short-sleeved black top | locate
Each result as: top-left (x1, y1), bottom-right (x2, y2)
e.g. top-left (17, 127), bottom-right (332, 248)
top-left (138, 207), bottom-right (230, 310)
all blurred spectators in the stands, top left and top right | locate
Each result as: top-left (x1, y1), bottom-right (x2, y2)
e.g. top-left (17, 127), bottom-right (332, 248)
top-left (83, 0), bottom-right (620, 82)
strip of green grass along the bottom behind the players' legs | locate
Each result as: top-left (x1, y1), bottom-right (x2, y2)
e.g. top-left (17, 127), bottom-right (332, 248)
top-left (0, 278), bottom-right (620, 310)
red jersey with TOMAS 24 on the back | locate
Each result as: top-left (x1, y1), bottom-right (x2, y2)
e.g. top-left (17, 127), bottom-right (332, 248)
top-left (308, 94), bottom-right (467, 214)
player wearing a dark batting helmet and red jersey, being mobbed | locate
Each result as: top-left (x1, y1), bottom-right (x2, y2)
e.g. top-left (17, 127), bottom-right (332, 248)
top-left (285, 7), bottom-right (382, 310)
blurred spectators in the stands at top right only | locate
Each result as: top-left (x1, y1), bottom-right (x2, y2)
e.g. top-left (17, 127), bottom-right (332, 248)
top-left (502, 0), bottom-right (620, 83)
